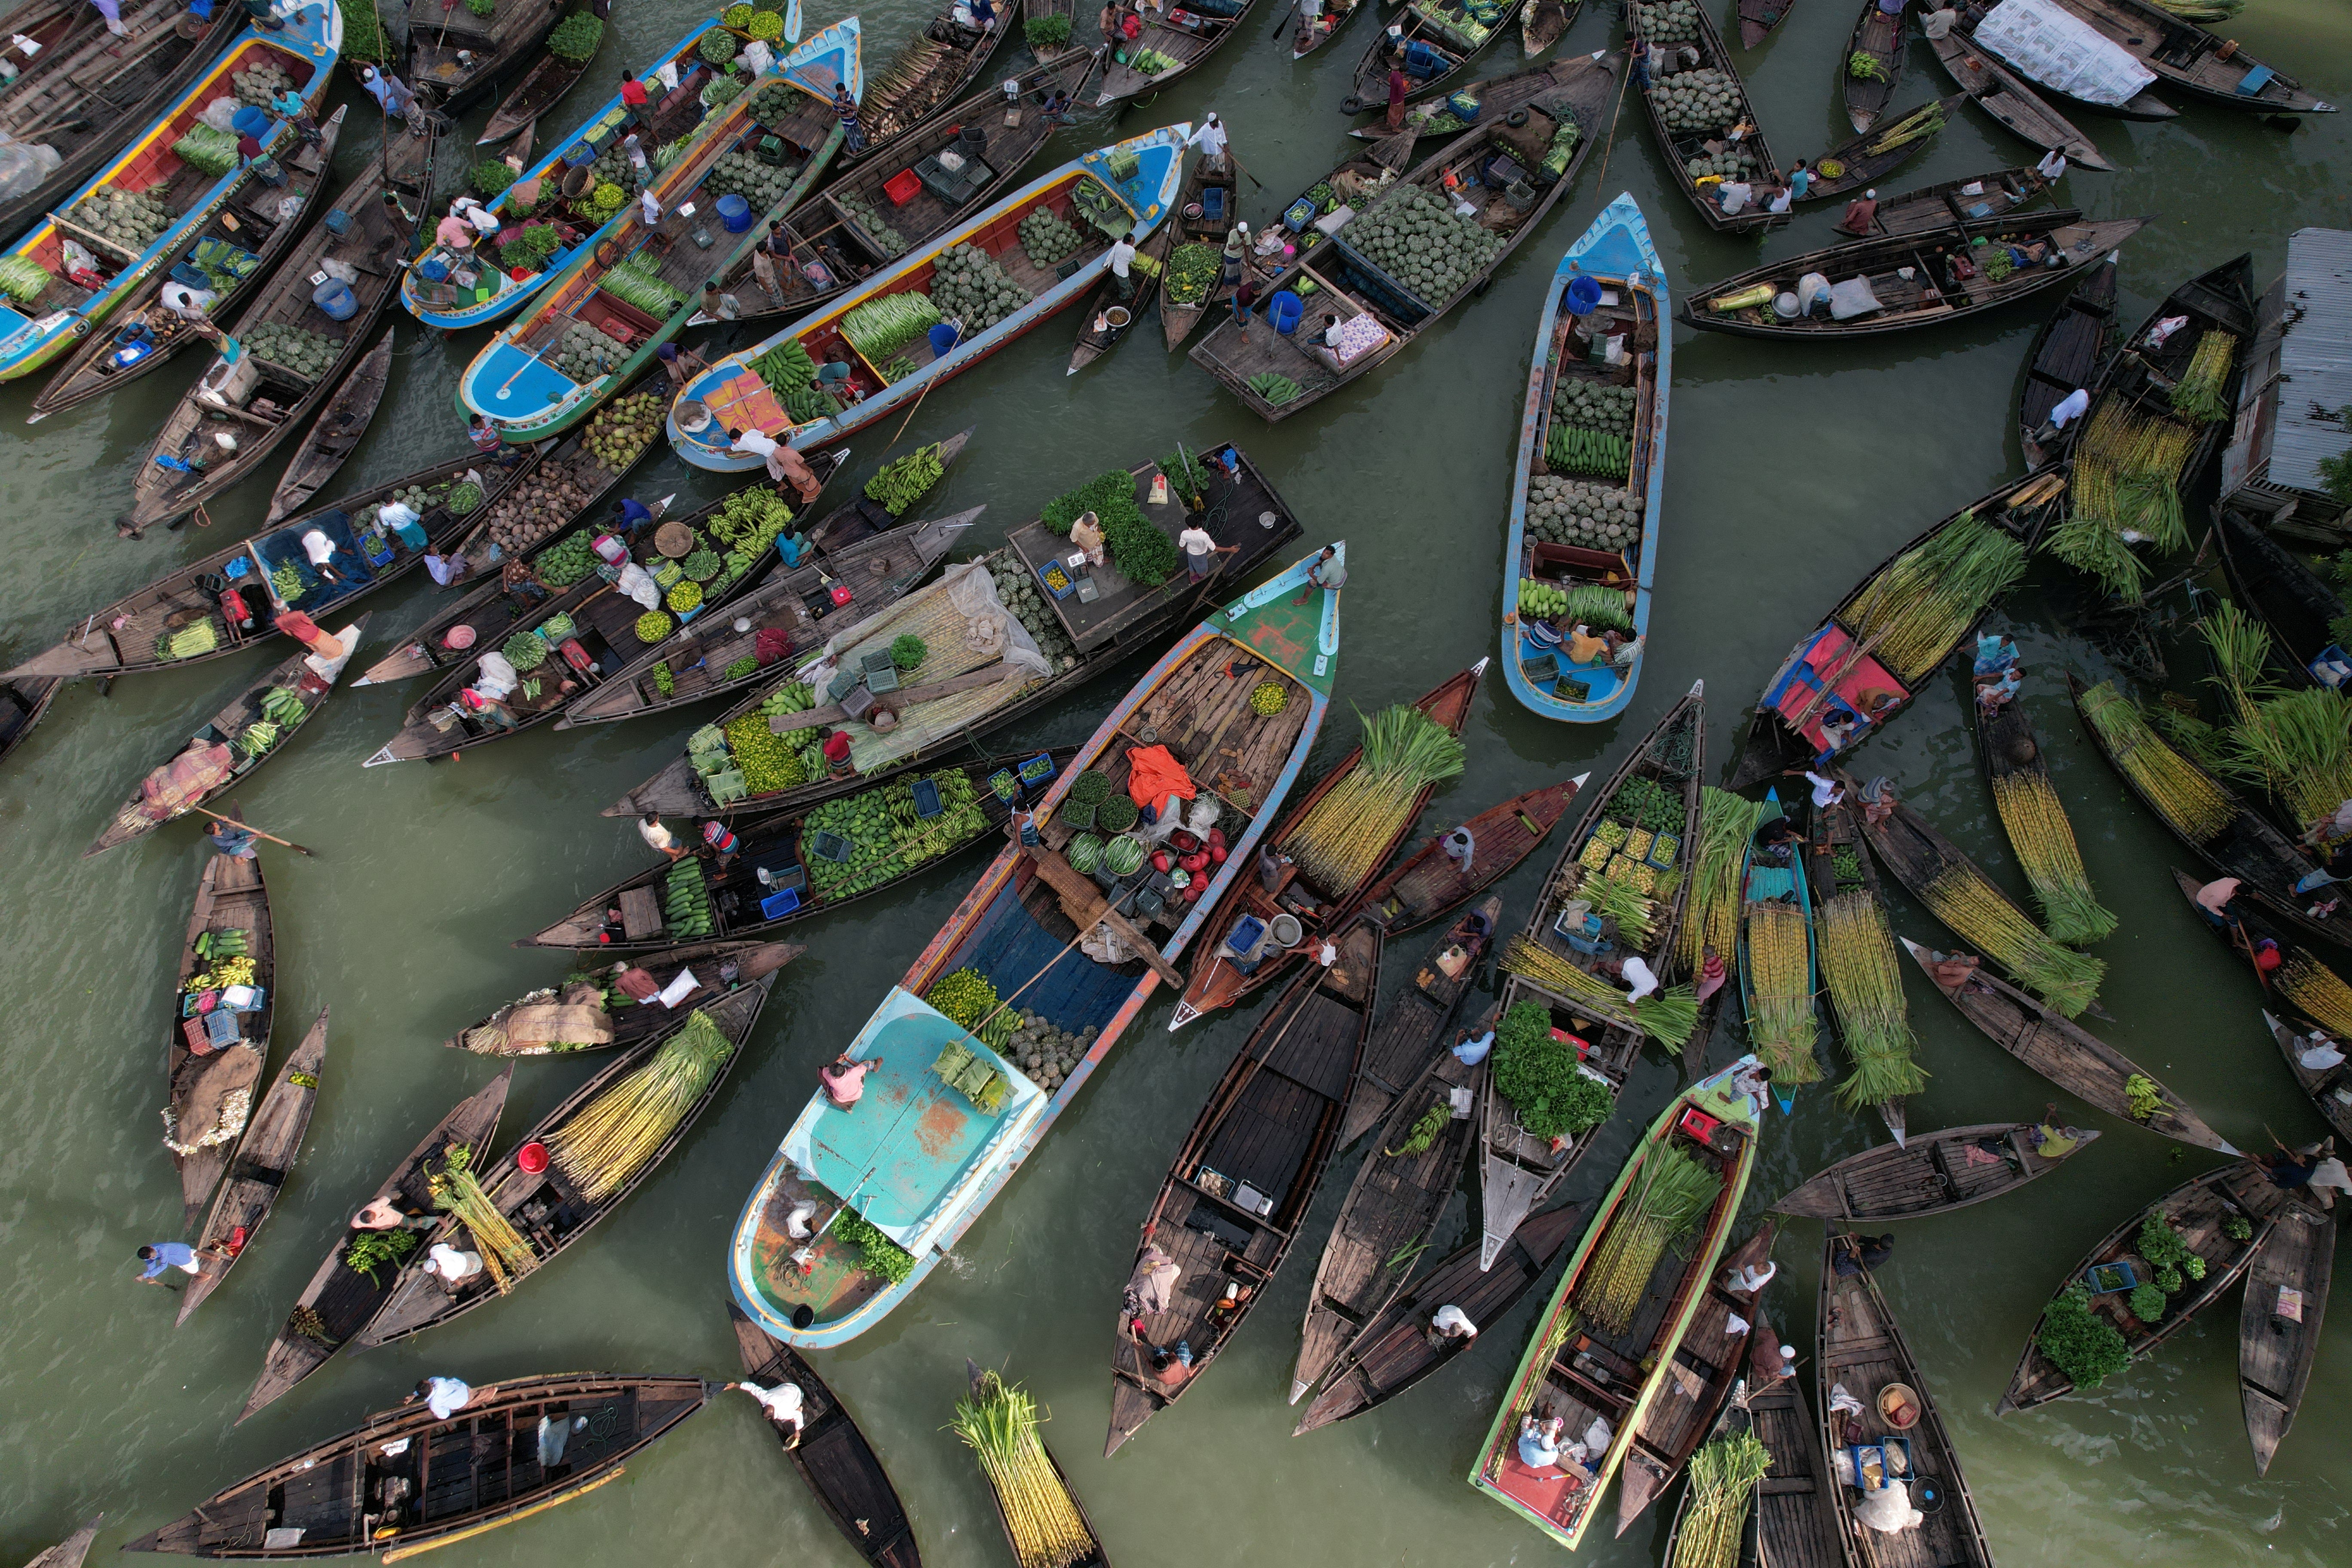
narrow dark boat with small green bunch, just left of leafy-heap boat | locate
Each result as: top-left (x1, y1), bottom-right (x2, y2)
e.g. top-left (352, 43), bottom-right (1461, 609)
top-left (1298, 987), bottom-right (1501, 1403)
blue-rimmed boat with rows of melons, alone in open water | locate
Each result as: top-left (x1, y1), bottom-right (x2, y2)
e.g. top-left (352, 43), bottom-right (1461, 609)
top-left (1503, 195), bottom-right (1675, 724)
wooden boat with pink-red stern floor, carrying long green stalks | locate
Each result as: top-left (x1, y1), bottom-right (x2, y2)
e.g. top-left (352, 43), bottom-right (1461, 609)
top-left (1724, 468), bottom-right (2065, 790)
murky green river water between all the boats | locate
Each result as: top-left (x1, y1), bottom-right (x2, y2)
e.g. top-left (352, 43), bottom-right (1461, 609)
top-left (0, 0), bottom-right (2352, 1568)
